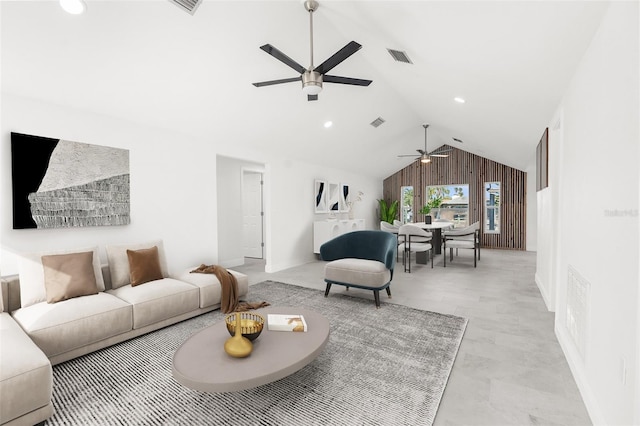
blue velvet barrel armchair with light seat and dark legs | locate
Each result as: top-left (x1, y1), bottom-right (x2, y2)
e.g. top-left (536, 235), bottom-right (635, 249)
top-left (320, 231), bottom-right (398, 308)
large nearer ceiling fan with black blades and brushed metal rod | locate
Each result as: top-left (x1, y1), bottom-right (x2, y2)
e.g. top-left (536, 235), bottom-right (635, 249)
top-left (253, 0), bottom-right (371, 101)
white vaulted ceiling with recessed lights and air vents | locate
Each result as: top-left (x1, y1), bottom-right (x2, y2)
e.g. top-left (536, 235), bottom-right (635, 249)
top-left (1, 0), bottom-right (607, 178)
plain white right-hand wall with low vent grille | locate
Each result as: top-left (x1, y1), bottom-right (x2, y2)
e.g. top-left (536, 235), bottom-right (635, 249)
top-left (538, 2), bottom-right (640, 425)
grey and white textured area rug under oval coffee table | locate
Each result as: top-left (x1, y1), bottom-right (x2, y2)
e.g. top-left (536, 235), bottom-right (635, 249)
top-left (47, 281), bottom-right (467, 426)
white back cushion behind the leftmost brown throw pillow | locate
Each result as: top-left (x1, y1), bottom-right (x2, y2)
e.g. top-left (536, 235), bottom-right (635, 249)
top-left (18, 247), bottom-right (104, 308)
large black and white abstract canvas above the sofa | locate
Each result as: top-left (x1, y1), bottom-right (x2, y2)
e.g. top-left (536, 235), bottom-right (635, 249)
top-left (11, 133), bottom-right (131, 229)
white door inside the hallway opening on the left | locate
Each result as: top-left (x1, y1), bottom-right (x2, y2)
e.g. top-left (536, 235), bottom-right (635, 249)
top-left (242, 171), bottom-right (264, 259)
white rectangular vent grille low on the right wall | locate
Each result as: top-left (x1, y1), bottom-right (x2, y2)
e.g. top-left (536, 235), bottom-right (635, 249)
top-left (566, 265), bottom-right (591, 360)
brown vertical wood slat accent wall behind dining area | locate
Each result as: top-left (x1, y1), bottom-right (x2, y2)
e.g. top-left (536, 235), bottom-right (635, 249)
top-left (383, 145), bottom-right (527, 250)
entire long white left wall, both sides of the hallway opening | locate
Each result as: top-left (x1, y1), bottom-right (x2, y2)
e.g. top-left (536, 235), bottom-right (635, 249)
top-left (0, 93), bottom-right (382, 275)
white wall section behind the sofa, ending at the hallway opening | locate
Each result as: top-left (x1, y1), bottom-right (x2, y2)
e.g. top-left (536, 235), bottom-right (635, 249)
top-left (0, 94), bottom-right (217, 275)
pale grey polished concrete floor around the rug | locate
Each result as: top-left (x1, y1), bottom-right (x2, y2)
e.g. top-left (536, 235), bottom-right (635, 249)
top-left (233, 249), bottom-right (591, 426)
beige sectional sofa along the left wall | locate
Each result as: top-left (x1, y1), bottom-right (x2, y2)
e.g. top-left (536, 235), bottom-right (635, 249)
top-left (0, 241), bottom-right (249, 425)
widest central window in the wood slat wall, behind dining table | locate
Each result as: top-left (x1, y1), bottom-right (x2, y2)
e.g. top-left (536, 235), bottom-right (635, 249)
top-left (426, 184), bottom-right (469, 228)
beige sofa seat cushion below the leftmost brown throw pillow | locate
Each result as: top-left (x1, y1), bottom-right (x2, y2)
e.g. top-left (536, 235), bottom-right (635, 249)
top-left (13, 292), bottom-right (133, 358)
